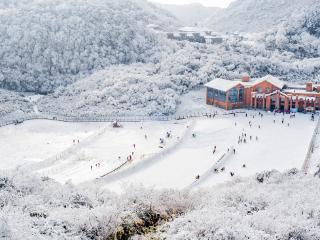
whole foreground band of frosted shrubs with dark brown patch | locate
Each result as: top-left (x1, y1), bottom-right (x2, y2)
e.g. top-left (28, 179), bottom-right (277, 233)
top-left (0, 171), bottom-right (320, 240)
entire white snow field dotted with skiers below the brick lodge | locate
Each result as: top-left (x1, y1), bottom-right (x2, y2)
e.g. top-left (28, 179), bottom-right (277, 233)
top-left (0, 111), bottom-right (316, 192)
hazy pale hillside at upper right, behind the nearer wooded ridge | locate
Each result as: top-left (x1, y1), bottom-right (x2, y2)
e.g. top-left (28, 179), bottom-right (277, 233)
top-left (203, 0), bottom-right (318, 32)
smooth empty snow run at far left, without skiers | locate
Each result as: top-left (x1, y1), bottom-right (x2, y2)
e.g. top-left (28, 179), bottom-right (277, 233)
top-left (0, 120), bottom-right (101, 170)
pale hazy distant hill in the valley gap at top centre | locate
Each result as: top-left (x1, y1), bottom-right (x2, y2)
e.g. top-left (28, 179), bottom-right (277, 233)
top-left (158, 3), bottom-right (221, 26)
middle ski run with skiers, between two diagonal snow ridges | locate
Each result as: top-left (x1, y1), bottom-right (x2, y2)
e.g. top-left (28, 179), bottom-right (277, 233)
top-left (45, 120), bottom-right (190, 183)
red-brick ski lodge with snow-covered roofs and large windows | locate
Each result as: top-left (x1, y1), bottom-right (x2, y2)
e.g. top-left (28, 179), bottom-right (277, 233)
top-left (205, 75), bottom-right (320, 112)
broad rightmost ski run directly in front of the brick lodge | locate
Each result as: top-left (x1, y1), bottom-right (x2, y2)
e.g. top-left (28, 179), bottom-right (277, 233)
top-left (101, 112), bottom-right (315, 192)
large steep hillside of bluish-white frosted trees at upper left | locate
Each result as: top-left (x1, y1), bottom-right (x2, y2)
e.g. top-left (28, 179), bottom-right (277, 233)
top-left (0, 0), bottom-right (176, 93)
